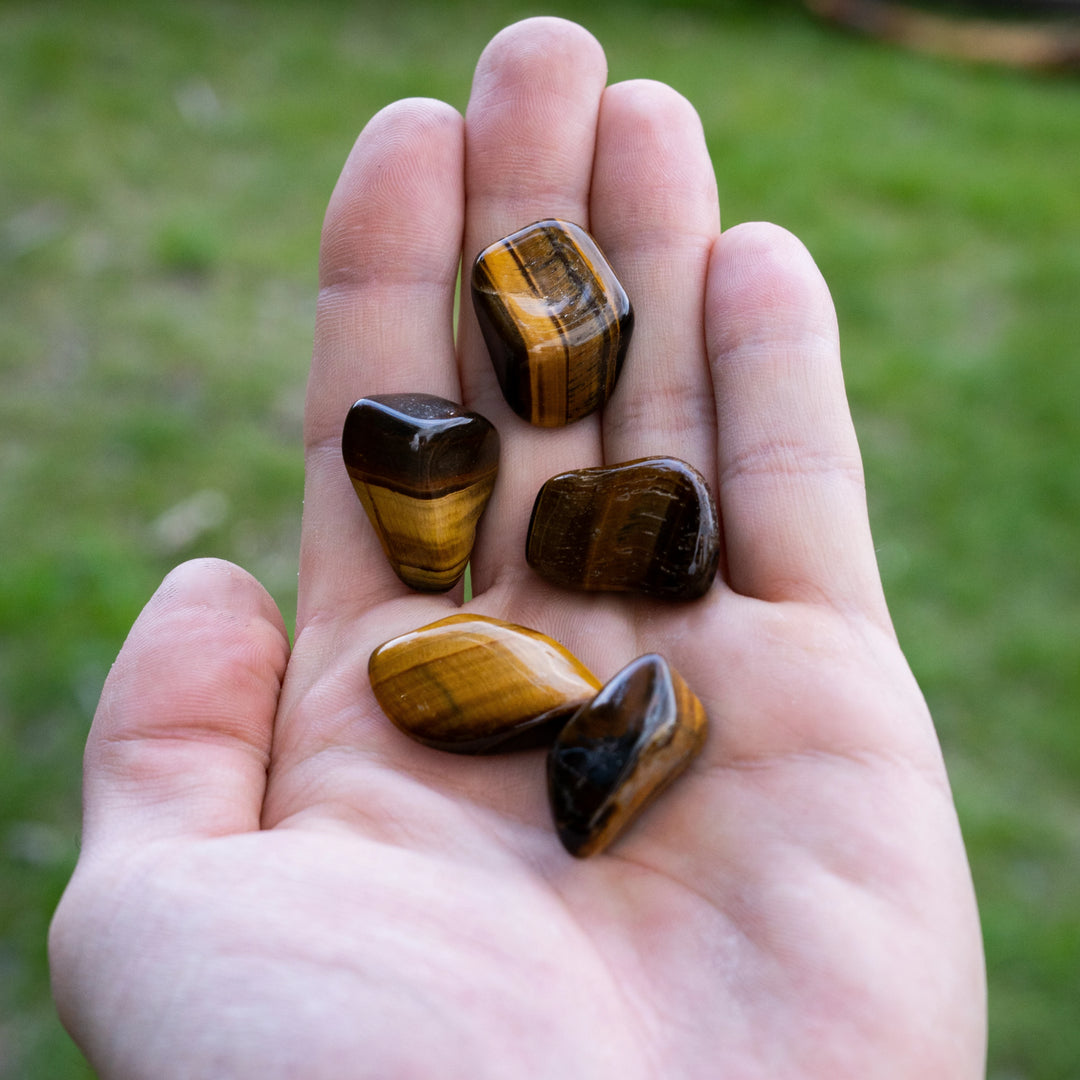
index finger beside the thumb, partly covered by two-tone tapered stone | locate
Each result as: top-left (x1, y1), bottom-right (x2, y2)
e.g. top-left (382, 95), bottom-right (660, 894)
top-left (297, 98), bottom-right (464, 631)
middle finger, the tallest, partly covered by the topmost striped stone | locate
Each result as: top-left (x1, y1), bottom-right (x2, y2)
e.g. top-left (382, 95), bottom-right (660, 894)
top-left (459, 18), bottom-right (618, 593)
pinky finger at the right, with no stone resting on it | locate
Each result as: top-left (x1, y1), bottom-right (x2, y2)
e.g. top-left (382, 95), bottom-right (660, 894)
top-left (706, 224), bottom-right (889, 625)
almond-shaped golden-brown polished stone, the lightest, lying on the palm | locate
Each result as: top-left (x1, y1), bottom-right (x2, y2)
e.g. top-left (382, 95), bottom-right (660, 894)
top-left (368, 615), bottom-right (600, 754)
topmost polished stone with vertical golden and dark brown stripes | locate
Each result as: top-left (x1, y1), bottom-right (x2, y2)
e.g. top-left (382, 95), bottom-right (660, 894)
top-left (472, 219), bottom-right (634, 428)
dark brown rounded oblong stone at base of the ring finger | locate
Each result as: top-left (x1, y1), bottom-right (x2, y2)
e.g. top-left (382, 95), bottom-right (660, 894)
top-left (525, 458), bottom-right (720, 600)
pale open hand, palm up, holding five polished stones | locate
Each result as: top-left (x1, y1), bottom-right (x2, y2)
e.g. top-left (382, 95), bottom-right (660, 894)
top-left (50, 19), bottom-right (986, 1080)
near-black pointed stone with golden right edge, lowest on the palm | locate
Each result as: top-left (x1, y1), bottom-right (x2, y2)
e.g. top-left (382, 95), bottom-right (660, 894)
top-left (548, 653), bottom-right (708, 858)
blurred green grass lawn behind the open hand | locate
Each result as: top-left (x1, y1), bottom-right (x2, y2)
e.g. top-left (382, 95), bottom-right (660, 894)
top-left (0, 0), bottom-right (1080, 1080)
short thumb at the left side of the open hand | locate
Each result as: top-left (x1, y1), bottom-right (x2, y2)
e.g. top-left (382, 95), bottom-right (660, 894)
top-left (83, 559), bottom-right (288, 852)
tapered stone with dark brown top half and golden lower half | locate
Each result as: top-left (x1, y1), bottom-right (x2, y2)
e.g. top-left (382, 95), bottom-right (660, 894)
top-left (341, 394), bottom-right (499, 592)
